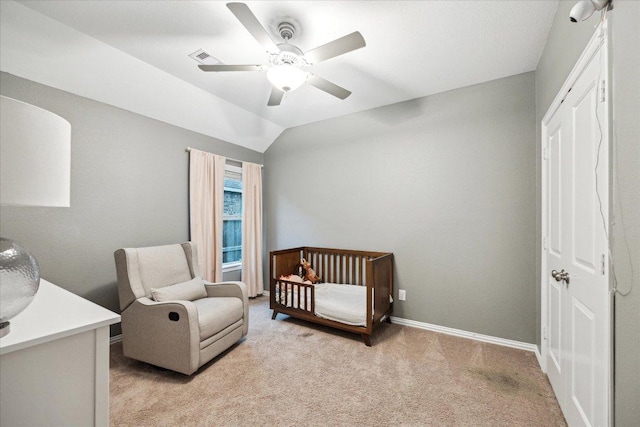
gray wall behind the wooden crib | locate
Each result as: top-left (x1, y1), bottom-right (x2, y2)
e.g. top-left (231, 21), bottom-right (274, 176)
top-left (264, 73), bottom-right (536, 343)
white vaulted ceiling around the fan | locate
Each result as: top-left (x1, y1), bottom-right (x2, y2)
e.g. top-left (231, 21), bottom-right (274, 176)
top-left (0, 0), bottom-right (558, 152)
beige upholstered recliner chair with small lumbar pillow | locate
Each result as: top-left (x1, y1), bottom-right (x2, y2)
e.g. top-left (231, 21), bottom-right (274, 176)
top-left (114, 242), bottom-right (249, 375)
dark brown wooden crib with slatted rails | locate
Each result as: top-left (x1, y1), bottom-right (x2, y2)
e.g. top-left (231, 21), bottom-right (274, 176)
top-left (269, 247), bottom-right (393, 346)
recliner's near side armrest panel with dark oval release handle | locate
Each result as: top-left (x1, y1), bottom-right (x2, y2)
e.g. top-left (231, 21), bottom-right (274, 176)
top-left (122, 297), bottom-right (200, 375)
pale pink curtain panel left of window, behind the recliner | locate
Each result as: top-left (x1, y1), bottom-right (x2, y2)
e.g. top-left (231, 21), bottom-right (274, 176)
top-left (189, 149), bottom-right (227, 282)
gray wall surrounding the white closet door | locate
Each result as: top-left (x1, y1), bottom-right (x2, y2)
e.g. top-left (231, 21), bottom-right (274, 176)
top-left (536, 0), bottom-right (640, 427)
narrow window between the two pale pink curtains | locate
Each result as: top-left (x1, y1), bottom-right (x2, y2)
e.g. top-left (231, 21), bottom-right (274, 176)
top-left (222, 165), bottom-right (242, 270)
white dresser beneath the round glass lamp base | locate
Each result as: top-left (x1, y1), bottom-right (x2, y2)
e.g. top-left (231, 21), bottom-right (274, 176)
top-left (0, 279), bottom-right (120, 427)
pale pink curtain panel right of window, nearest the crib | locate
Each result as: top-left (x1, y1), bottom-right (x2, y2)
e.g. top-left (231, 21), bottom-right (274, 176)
top-left (242, 162), bottom-right (264, 297)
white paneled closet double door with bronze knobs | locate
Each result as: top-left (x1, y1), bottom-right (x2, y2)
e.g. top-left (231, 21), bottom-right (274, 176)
top-left (545, 33), bottom-right (610, 426)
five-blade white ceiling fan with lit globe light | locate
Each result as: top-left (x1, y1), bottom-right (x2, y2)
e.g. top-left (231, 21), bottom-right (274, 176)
top-left (198, 3), bottom-right (366, 106)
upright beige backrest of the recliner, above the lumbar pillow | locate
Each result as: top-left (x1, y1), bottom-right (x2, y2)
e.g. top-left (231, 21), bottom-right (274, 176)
top-left (114, 242), bottom-right (197, 310)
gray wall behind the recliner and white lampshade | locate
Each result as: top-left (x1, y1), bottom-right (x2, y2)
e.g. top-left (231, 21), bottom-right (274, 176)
top-left (0, 73), bottom-right (262, 334)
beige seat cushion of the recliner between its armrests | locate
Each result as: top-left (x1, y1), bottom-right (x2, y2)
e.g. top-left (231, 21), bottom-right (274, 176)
top-left (193, 297), bottom-right (244, 341)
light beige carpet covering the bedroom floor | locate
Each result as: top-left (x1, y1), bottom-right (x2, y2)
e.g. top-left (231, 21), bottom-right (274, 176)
top-left (110, 297), bottom-right (566, 427)
